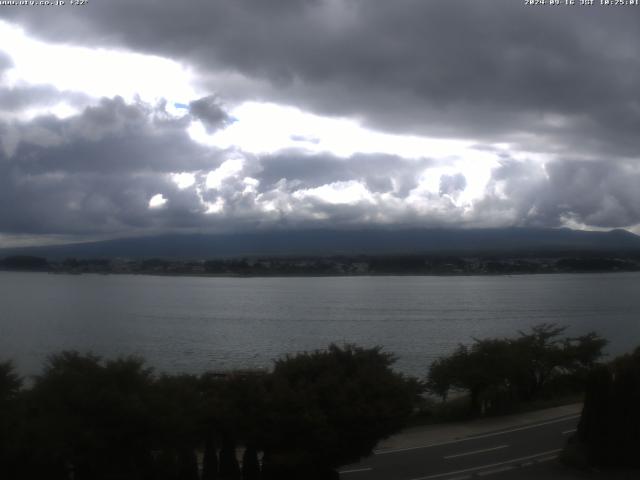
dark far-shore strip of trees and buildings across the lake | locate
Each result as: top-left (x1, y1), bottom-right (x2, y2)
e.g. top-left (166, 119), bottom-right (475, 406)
top-left (0, 252), bottom-right (640, 276)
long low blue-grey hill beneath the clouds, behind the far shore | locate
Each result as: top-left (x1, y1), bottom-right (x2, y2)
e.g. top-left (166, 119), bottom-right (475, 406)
top-left (0, 228), bottom-right (640, 259)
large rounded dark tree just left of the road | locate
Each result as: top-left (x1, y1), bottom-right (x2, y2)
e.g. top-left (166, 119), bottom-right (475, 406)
top-left (262, 345), bottom-right (421, 479)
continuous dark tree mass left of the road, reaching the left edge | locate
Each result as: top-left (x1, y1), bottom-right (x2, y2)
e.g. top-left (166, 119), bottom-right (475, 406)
top-left (0, 346), bottom-right (419, 480)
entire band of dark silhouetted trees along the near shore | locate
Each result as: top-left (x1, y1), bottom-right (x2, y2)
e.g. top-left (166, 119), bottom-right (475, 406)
top-left (0, 324), bottom-right (640, 480)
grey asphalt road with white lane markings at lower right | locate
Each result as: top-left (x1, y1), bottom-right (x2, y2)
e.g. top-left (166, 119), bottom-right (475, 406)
top-left (340, 415), bottom-right (579, 480)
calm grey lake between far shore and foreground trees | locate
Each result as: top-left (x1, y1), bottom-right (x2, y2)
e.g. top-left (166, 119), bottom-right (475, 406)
top-left (0, 272), bottom-right (640, 376)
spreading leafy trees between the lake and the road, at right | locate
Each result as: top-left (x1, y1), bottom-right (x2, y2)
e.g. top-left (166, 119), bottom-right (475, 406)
top-left (427, 323), bottom-right (607, 414)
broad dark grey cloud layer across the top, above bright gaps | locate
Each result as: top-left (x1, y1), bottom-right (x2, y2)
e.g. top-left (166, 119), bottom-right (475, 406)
top-left (2, 0), bottom-right (640, 153)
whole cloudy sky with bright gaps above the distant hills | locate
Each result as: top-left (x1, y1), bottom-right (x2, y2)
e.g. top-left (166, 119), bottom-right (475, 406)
top-left (0, 0), bottom-right (640, 246)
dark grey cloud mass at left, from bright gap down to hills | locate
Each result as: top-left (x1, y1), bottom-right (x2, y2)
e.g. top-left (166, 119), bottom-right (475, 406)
top-left (0, 98), bottom-right (222, 234)
